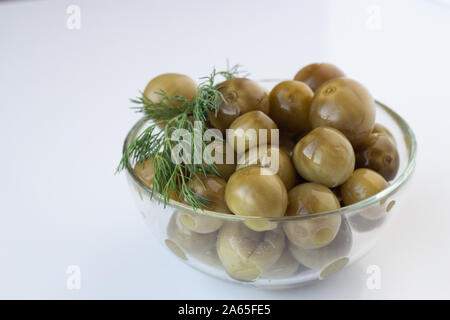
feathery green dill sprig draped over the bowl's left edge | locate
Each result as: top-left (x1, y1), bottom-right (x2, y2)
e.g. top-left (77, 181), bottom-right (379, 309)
top-left (117, 65), bottom-right (242, 209)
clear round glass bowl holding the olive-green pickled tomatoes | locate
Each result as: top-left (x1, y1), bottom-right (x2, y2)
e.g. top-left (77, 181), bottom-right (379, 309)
top-left (124, 80), bottom-right (417, 289)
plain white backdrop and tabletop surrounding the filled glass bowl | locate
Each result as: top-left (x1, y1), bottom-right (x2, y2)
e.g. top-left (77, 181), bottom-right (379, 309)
top-left (0, 0), bottom-right (450, 299)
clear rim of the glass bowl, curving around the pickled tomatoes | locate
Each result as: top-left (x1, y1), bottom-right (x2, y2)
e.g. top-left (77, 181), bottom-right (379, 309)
top-left (122, 100), bottom-right (417, 222)
